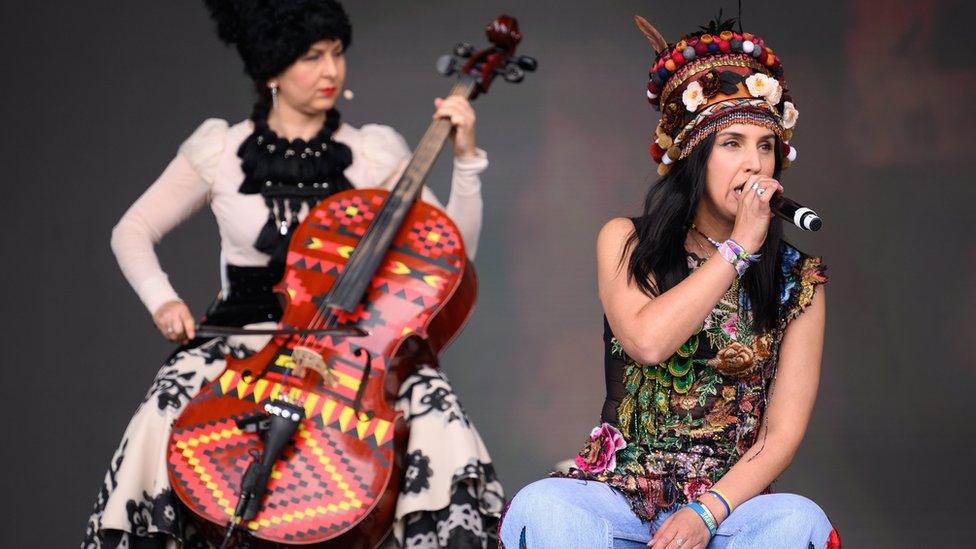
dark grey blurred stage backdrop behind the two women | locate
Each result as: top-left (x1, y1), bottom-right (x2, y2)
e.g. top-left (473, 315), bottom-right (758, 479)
top-left (0, 0), bottom-right (976, 548)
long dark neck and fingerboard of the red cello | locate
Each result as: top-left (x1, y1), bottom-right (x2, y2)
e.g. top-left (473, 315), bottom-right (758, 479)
top-left (321, 74), bottom-right (478, 312)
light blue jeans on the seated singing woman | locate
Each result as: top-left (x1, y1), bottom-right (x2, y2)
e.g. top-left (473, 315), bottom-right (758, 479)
top-left (501, 478), bottom-right (832, 549)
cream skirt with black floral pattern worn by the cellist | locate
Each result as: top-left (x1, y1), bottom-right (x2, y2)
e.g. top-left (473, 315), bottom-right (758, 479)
top-left (81, 330), bottom-right (504, 549)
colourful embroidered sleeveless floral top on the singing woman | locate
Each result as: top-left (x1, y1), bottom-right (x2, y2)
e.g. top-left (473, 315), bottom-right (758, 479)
top-left (555, 215), bottom-right (827, 521)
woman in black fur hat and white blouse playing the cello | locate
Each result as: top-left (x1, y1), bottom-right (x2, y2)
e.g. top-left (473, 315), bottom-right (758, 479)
top-left (82, 0), bottom-right (503, 548)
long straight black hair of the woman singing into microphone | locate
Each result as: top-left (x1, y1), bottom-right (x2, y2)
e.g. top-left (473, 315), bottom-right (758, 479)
top-left (621, 134), bottom-right (784, 332)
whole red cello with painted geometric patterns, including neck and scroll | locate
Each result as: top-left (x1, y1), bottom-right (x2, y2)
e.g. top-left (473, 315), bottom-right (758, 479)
top-left (168, 15), bottom-right (536, 547)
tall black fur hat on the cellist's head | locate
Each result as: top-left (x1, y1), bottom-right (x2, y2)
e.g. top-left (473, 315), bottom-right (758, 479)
top-left (204, 0), bottom-right (352, 84)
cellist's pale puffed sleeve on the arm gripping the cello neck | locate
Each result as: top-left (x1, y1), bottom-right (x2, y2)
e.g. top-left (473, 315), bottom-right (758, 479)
top-left (360, 124), bottom-right (488, 259)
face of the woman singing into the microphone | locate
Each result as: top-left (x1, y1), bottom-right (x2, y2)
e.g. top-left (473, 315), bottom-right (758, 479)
top-left (705, 124), bottom-right (776, 223)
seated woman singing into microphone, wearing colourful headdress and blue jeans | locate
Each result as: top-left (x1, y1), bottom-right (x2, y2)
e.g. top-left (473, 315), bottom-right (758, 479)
top-left (501, 12), bottom-right (839, 549)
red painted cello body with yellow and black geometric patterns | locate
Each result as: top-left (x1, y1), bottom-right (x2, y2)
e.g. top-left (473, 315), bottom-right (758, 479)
top-left (170, 190), bottom-right (477, 547)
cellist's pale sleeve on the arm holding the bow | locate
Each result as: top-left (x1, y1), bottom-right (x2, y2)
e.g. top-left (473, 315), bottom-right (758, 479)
top-left (111, 119), bottom-right (228, 314)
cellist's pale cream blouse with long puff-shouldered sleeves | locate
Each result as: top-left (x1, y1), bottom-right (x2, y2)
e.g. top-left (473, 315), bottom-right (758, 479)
top-left (112, 118), bottom-right (488, 313)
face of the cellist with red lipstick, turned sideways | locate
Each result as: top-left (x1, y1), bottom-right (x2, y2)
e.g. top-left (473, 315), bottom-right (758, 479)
top-left (269, 40), bottom-right (346, 115)
